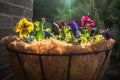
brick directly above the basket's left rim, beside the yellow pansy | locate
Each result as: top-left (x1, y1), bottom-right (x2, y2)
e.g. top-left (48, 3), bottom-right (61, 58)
top-left (0, 29), bottom-right (16, 39)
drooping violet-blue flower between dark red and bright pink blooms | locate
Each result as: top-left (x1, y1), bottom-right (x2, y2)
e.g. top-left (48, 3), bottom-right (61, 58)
top-left (68, 21), bottom-right (80, 38)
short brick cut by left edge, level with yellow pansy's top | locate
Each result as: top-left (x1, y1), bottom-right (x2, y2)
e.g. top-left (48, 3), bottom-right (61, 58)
top-left (0, 15), bottom-right (11, 27)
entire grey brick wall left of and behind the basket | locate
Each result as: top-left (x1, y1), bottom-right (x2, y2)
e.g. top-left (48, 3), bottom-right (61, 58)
top-left (0, 0), bottom-right (33, 80)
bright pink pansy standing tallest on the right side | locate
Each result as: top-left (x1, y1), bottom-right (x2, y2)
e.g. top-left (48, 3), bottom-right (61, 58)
top-left (81, 16), bottom-right (95, 29)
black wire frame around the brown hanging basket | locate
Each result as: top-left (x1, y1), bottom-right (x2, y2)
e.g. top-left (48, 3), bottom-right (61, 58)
top-left (7, 47), bottom-right (112, 80)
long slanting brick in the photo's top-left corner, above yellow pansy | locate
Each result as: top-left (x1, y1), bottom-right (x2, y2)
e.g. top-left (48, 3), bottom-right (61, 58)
top-left (0, 0), bottom-right (24, 16)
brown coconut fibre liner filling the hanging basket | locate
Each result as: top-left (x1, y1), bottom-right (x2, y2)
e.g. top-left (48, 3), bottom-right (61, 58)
top-left (4, 36), bottom-right (114, 80)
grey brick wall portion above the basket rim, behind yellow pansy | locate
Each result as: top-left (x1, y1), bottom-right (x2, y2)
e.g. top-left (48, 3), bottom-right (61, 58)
top-left (0, 0), bottom-right (33, 39)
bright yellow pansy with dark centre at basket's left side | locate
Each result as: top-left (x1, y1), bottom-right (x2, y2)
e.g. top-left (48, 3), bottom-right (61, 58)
top-left (15, 18), bottom-right (34, 37)
